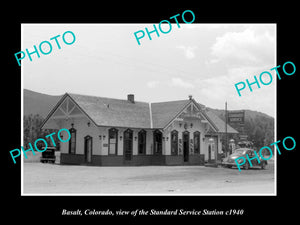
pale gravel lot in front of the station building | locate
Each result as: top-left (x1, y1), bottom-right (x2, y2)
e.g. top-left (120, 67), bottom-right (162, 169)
top-left (23, 160), bottom-right (275, 195)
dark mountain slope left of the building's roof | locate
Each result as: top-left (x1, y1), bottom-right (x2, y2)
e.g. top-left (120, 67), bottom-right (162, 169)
top-left (23, 89), bottom-right (62, 118)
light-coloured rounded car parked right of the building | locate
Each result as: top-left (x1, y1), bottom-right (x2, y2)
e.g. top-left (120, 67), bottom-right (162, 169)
top-left (222, 148), bottom-right (268, 170)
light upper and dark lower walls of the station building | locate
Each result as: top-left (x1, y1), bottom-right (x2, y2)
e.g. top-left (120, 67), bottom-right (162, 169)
top-left (60, 114), bottom-right (221, 165)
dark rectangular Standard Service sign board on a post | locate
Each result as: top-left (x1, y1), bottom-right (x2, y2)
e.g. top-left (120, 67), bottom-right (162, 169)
top-left (227, 110), bottom-right (248, 140)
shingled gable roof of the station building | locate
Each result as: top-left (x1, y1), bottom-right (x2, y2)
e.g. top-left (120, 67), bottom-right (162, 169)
top-left (48, 93), bottom-right (237, 133)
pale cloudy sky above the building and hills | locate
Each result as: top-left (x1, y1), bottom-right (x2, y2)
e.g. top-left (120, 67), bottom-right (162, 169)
top-left (22, 21), bottom-right (277, 117)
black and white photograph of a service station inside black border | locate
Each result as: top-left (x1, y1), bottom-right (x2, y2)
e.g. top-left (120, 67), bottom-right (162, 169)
top-left (21, 21), bottom-right (277, 195)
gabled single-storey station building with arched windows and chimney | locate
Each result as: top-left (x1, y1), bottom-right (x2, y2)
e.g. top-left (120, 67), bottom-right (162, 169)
top-left (42, 93), bottom-right (237, 166)
